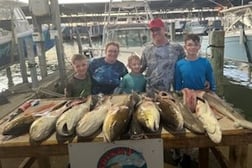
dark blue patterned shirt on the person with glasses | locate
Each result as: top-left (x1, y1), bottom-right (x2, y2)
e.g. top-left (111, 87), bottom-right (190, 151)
top-left (89, 57), bottom-right (128, 94)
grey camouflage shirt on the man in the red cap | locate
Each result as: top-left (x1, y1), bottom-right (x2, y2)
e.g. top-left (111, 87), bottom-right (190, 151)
top-left (141, 42), bottom-right (185, 93)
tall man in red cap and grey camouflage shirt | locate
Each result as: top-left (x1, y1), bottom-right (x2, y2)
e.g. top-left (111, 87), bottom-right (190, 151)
top-left (141, 18), bottom-right (185, 96)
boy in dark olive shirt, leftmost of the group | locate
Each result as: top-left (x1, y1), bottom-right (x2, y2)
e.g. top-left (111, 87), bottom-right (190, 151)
top-left (65, 54), bottom-right (91, 97)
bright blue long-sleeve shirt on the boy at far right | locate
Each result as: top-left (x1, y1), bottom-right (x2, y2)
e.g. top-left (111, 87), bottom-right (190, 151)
top-left (174, 57), bottom-right (216, 91)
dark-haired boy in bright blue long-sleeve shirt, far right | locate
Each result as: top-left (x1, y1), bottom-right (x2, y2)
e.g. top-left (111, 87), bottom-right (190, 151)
top-left (174, 34), bottom-right (216, 91)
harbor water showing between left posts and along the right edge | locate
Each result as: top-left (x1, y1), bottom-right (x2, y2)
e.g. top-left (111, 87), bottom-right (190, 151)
top-left (0, 37), bottom-right (252, 121)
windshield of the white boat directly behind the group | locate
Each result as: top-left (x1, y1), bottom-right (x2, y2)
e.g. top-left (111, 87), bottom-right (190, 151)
top-left (108, 28), bottom-right (150, 47)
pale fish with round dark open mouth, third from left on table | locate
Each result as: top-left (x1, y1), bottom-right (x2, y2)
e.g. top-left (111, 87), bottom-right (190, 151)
top-left (56, 96), bottom-right (92, 136)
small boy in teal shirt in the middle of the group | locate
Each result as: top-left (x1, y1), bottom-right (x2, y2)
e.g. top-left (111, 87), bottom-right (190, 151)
top-left (114, 55), bottom-right (146, 93)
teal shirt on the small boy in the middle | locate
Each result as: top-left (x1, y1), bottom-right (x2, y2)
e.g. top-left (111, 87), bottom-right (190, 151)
top-left (119, 73), bottom-right (146, 93)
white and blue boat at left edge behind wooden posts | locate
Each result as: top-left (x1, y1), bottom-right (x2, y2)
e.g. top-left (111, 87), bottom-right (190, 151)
top-left (0, 4), bottom-right (54, 69)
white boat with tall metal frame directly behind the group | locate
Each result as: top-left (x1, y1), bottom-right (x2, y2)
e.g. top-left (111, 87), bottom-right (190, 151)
top-left (102, 0), bottom-right (153, 63)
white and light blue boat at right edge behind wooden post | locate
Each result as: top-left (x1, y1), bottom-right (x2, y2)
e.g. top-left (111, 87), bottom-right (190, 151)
top-left (202, 4), bottom-right (252, 63)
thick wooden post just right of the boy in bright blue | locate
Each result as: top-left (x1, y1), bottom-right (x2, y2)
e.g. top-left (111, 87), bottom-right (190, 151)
top-left (209, 30), bottom-right (225, 96)
